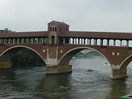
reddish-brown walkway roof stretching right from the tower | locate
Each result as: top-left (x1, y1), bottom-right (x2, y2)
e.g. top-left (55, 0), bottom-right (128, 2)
top-left (59, 31), bottom-right (132, 39)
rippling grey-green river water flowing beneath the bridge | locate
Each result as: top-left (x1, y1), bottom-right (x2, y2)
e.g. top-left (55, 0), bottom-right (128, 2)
top-left (0, 56), bottom-right (132, 99)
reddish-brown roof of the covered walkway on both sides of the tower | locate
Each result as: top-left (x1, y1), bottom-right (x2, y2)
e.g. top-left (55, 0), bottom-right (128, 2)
top-left (0, 31), bottom-right (132, 39)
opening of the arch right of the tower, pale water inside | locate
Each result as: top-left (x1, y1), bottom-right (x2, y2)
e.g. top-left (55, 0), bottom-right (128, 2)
top-left (59, 48), bottom-right (111, 72)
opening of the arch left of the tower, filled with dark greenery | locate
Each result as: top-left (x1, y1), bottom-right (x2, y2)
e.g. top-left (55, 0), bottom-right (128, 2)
top-left (0, 46), bottom-right (45, 68)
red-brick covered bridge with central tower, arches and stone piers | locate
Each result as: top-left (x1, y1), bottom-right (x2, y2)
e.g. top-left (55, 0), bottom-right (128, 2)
top-left (0, 21), bottom-right (132, 78)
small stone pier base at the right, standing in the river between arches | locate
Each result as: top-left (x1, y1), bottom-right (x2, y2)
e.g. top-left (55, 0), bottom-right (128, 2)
top-left (111, 68), bottom-right (128, 79)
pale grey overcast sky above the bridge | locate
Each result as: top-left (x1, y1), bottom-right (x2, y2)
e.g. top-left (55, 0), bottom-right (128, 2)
top-left (0, 0), bottom-right (132, 32)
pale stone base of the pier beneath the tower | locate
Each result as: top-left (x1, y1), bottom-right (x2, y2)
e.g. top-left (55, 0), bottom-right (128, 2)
top-left (46, 65), bottom-right (72, 74)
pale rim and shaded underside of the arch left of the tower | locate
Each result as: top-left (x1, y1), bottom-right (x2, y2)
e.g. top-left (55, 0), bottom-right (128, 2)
top-left (0, 45), bottom-right (46, 67)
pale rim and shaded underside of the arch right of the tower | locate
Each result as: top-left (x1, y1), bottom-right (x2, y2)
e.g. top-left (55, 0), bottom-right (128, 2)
top-left (58, 47), bottom-right (111, 65)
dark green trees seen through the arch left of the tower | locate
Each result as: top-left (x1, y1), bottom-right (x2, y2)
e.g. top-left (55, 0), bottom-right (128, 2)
top-left (11, 48), bottom-right (44, 67)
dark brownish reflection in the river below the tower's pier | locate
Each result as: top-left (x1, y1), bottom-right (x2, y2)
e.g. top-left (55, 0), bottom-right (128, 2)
top-left (36, 74), bottom-right (71, 99)
